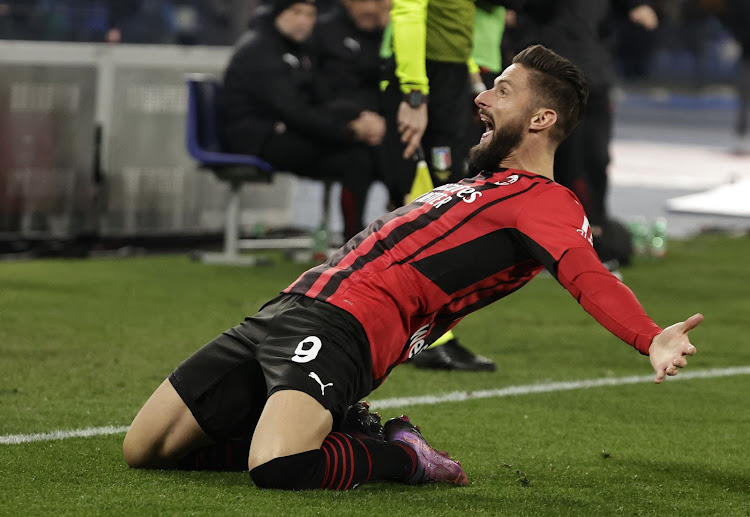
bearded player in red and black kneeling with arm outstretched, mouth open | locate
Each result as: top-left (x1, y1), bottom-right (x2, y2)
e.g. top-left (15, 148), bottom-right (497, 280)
top-left (123, 45), bottom-right (703, 489)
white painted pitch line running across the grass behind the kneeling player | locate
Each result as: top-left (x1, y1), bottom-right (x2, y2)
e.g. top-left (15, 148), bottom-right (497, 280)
top-left (0, 366), bottom-right (750, 445)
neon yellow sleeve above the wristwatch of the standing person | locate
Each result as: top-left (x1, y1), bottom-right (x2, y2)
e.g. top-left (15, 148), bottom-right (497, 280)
top-left (391, 0), bottom-right (429, 94)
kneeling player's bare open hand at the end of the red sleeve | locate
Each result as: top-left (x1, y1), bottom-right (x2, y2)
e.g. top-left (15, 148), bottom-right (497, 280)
top-left (648, 314), bottom-right (703, 384)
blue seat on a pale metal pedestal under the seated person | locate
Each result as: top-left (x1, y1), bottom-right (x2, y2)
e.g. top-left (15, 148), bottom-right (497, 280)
top-left (187, 74), bottom-right (312, 265)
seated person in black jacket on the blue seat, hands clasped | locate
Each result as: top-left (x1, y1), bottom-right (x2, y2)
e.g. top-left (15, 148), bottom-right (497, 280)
top-left (219, 0), bottom-right (385, 239)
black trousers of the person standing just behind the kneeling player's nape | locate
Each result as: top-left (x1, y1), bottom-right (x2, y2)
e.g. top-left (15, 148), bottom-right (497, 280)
top-left (555, 85), bottom-right (612, 226)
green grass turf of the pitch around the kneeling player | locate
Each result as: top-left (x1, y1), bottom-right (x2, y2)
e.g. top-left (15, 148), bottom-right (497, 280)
top-left (0, 235), bottom-right (750, 516)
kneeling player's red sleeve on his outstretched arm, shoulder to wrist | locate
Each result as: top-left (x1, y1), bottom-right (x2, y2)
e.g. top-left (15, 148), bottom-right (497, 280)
top-left (518, 186), bottom-right (661, 355)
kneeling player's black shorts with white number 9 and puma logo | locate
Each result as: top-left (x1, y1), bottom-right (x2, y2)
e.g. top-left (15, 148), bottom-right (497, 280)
top-left (169, 295), bottom-right (373, 440)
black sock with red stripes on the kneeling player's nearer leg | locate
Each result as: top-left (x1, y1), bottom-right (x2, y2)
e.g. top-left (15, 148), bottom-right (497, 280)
top-left (250, 433), bottom-right (416, 490)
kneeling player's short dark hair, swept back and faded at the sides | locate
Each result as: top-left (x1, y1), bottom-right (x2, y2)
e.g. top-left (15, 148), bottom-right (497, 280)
top-left (513, 45), bottom-right (589, 143)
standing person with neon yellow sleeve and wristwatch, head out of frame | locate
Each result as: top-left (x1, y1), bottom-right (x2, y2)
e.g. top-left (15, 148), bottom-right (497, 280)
top-left (384, 0), bottom-right (475, 206)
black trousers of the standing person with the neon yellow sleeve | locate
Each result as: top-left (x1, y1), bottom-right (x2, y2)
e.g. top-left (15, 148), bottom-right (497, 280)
top-left (382, 60), bottom-right (470, 206)
